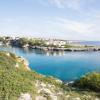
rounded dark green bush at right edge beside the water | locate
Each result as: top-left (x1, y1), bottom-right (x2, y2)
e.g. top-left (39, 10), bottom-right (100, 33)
top-left (73, 72), bottom-right (100, 91)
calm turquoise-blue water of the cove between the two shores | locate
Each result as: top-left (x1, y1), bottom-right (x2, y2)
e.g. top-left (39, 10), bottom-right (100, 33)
top-left (0, 46), bottom-right (100, 81)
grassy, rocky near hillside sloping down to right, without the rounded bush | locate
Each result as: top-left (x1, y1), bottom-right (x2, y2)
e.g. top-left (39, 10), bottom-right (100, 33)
top-left (0, 52), bottom-right (100, 100)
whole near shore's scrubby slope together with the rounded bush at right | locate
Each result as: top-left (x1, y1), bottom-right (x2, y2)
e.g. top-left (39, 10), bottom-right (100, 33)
top-left (0, 52), bottom-right (100, 100)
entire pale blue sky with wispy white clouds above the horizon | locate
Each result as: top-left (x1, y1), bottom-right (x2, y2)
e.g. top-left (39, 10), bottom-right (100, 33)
top-left (0, 0), bottom-right (100, 41)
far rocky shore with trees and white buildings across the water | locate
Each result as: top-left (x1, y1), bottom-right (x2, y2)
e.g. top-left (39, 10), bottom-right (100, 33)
top-left (0, 37), bottom-right (100, 52)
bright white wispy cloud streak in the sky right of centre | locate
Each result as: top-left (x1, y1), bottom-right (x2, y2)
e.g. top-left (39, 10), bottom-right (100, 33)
top-left (48, 17), bottom-right (91, 33)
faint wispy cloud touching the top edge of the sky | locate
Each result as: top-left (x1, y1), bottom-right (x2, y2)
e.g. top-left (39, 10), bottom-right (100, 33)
top-left (35, 0), bottom-right (81, 10)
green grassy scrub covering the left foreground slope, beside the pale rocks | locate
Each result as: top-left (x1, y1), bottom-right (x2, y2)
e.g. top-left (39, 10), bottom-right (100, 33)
top-left (0, 52), bottom-right (59, 100)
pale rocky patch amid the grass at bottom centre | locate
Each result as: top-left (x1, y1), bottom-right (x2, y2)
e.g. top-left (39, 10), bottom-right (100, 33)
top-left (35, 80), bottom-right (65, 100)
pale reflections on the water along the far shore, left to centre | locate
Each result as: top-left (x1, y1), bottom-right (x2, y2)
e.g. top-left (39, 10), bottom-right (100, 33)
top-left (0, 45), bottom-right (65, 56)
